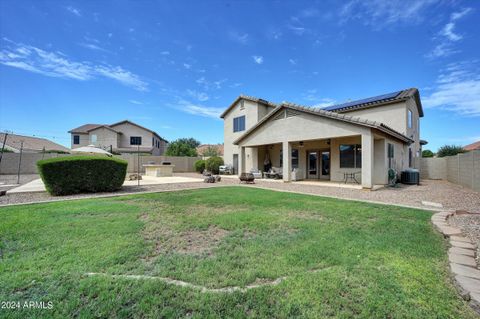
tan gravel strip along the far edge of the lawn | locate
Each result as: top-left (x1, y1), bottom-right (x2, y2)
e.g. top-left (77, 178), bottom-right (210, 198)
top-left (0, 173), bottom-right (480, 212)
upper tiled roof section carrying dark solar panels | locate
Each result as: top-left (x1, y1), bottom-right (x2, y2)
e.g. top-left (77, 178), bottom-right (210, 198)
top-left (323, 88), bottom-right (423, 117)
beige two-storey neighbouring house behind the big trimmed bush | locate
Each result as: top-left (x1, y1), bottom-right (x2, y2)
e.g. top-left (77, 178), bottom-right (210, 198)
top-left (69, 120), bottom-right (168, 155)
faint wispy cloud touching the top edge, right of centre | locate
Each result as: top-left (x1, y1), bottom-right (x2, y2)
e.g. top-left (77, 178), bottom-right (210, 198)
top-left (339, 0), bottom-right (437, 29)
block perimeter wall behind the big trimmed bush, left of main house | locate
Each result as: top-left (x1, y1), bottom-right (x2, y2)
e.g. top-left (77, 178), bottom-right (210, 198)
top-left (0, 153), bottom-right (201, 175)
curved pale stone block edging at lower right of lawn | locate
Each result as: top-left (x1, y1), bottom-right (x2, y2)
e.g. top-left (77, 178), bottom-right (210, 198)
top-left (432, 212), bottom-right (480, 314)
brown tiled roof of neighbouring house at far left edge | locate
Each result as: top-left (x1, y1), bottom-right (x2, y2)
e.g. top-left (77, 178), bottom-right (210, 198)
top-left (0, 133), bottom-right (70, 153)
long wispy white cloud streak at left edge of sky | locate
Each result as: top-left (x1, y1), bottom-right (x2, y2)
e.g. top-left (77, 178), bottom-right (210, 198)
top-left (0, 41), bottom-right (148, 91)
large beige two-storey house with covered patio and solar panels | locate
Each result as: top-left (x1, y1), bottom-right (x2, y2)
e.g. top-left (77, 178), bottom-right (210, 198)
top-left (221, 88), bottom-right (423, 188)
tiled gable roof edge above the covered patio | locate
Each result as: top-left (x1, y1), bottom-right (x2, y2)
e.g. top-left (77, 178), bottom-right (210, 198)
top-left (233, 102), bottom-right (413, 144)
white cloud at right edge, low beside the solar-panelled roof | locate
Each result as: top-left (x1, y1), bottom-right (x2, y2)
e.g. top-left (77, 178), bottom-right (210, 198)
top-left (422, 61), bottom-right (480, 116)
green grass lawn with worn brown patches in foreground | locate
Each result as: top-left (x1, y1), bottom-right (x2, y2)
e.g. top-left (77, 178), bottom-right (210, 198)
top-left (0, 187), bottom-right (475, 318)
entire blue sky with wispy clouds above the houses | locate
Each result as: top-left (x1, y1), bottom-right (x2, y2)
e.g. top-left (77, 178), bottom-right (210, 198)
top-left (0, 0), bottom-right (480, 150)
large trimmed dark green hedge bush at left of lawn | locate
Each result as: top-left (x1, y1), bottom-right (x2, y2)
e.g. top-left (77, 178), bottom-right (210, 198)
top-left (37, 155), bottom-right (128, 195)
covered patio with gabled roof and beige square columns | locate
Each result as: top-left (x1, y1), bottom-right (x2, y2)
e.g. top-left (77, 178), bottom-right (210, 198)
top-left (232, 108), bottom-right (408, 189)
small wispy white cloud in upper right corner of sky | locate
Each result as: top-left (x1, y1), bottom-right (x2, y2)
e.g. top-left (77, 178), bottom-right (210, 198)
top-left (426, 8), bottom-right (472, 59)
